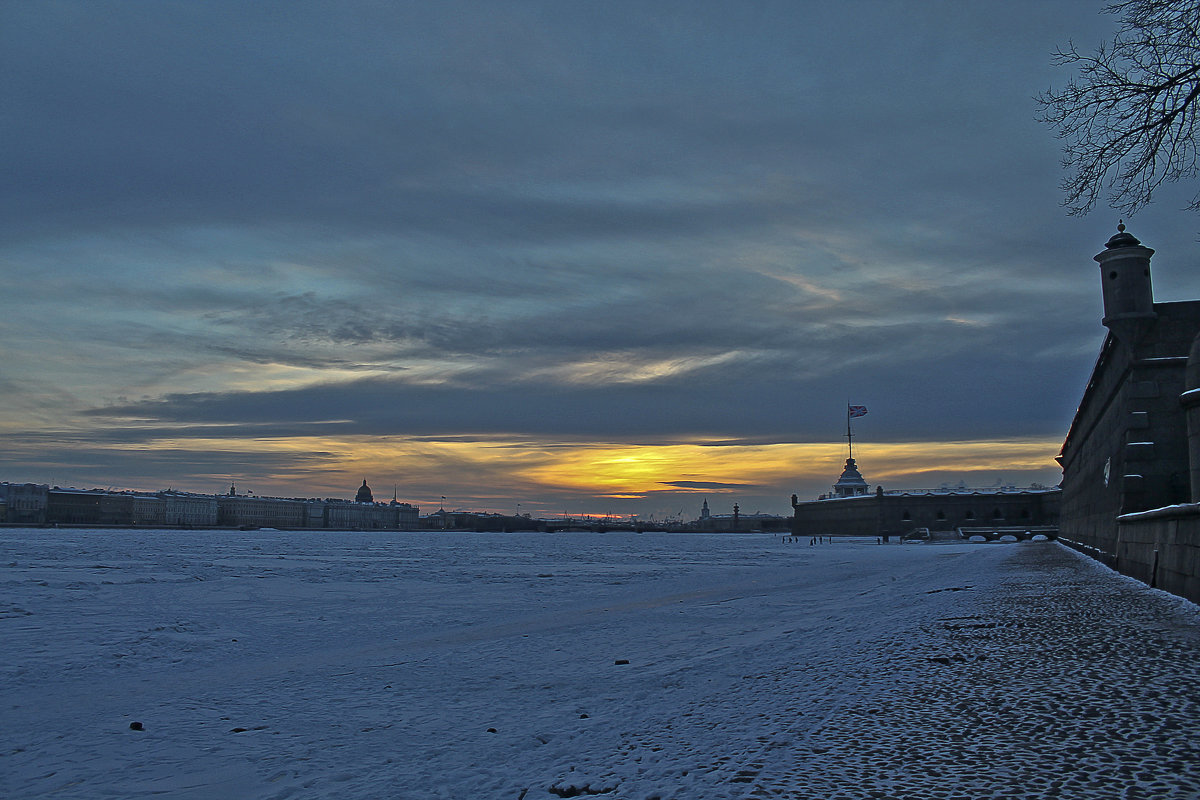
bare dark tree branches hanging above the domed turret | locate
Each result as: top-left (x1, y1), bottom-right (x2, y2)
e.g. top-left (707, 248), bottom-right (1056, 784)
top-left (1037, 0), bottom-right (1200, 216)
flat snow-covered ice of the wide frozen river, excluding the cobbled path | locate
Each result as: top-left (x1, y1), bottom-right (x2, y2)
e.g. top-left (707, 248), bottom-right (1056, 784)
top-left (7, 529), bottom-right (1200, 800)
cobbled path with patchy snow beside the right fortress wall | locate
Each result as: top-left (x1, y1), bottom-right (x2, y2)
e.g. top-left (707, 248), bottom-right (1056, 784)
top-left (749, 543), bottom-right (1200, 800)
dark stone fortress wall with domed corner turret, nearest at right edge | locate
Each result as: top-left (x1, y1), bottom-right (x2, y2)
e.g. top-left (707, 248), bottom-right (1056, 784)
top-left (1058, 224), bottom-right (1200, 600)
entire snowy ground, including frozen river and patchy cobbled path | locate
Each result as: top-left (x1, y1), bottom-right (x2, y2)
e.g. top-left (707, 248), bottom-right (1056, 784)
top-left (0, 529), bottom-right (1200, 800)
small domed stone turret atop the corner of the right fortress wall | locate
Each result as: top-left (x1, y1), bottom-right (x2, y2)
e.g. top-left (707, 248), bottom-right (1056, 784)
top-left (1096, 222), bottom-right (1156, 347)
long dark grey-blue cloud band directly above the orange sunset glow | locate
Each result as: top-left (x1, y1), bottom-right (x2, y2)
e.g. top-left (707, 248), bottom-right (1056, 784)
top-left (79, 340), bottom-right (1086, 443)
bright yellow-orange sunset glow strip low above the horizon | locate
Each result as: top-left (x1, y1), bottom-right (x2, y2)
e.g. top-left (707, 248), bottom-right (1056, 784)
top-left (93, 437), bottom-right (1061, 513)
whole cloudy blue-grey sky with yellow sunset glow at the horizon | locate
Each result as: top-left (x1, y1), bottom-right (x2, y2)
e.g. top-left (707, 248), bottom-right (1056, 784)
top-left (0, 0), bottom-right (1200, 518)
